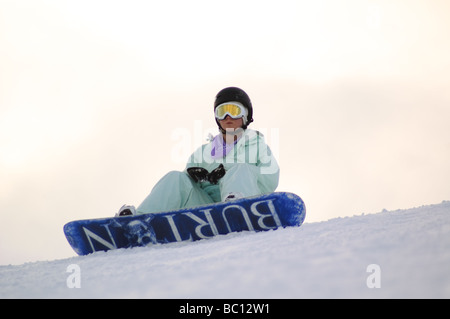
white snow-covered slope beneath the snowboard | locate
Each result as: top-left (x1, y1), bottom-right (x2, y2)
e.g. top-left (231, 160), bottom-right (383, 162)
top-left (0, 201), bottom-right (450, 298)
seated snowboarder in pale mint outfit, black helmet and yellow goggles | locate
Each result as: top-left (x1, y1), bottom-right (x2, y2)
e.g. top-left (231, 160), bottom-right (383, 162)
top-left (116, 87), bottom-right (280, 216)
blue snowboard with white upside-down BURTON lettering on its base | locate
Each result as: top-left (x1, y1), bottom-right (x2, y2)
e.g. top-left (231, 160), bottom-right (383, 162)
top-left (64, 193), bottom-right (306, 255)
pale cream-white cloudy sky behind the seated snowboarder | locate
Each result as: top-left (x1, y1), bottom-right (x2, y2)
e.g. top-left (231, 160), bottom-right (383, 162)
top-left (0, 0), bottom-right (450, 265)
